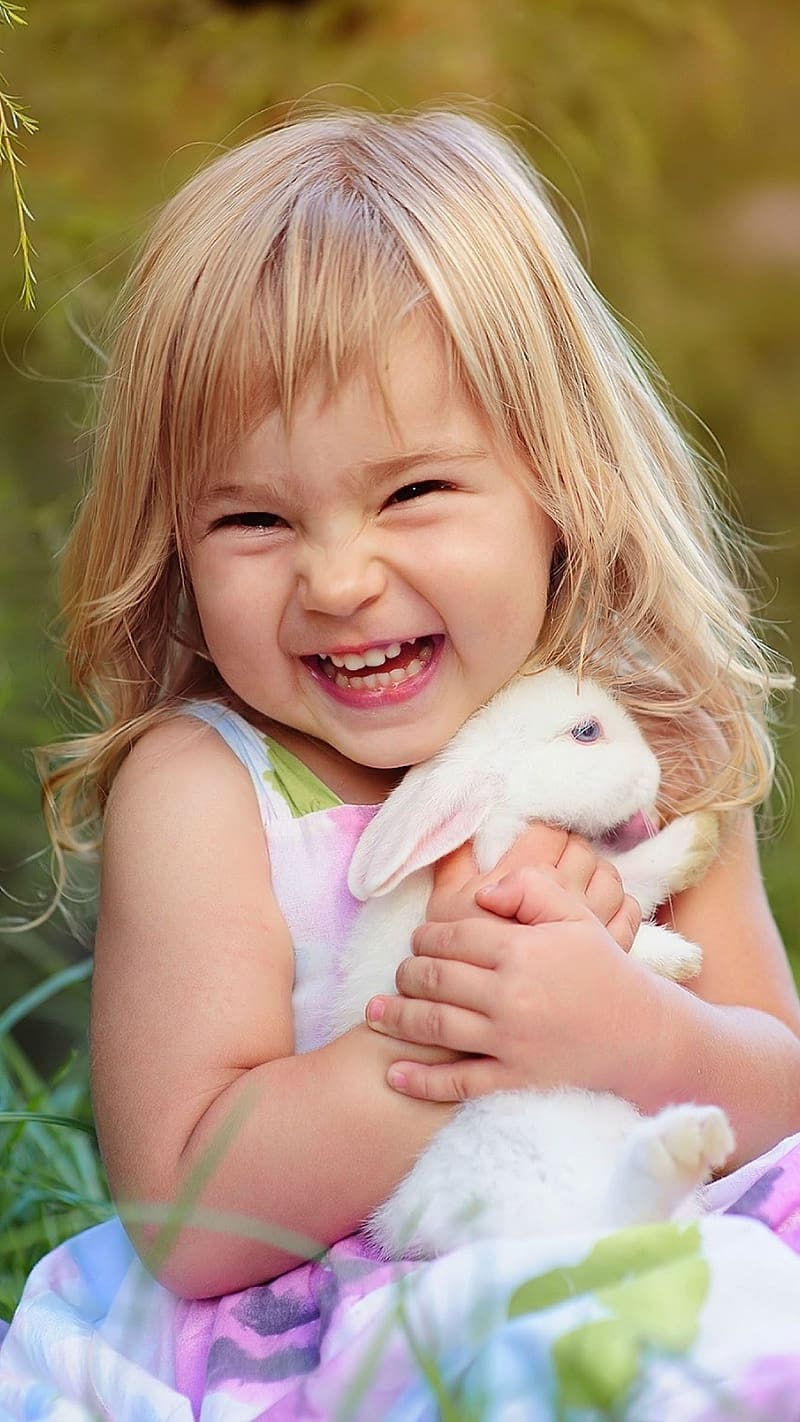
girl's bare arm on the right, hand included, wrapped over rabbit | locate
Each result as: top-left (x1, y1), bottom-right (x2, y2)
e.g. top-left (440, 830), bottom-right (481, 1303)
top-left (372, 815), bottom-right (800, 1166)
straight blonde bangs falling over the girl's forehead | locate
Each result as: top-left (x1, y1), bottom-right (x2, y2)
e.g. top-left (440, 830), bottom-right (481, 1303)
top-left (162, 191), bottom-right (439, 535)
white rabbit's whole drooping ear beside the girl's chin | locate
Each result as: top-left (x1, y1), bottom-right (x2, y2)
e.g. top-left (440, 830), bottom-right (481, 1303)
top-left (347, 766), bottom-right (502, 899)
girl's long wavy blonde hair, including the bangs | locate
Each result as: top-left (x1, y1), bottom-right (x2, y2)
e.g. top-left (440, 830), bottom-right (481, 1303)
top-left (44, 109), bottom-right (786, 849)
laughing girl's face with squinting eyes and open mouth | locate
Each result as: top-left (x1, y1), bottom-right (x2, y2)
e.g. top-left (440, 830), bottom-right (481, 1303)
top-left (189, 323), bottom-right (556, 802)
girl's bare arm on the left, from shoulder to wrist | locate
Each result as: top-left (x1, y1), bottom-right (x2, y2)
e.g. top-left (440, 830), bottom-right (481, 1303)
top-left (91, 718), bottom-right (449, 1295)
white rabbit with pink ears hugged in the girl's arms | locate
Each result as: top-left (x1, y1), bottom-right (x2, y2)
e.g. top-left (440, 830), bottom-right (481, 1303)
top-left (333, 668), bottom-right (733, 1258)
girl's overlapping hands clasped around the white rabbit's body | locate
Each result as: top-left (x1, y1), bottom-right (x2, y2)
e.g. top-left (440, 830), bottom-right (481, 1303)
top-left (367, 826), bottom-right (659, 1101)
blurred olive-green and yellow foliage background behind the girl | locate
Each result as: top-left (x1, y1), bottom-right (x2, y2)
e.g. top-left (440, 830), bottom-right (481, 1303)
top-left (0, 0), bottom-right (800, 1072)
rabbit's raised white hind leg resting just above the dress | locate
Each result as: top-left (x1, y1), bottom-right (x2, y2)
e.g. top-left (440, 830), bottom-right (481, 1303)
top-left (608, 1103), bottom-right (735, 1227)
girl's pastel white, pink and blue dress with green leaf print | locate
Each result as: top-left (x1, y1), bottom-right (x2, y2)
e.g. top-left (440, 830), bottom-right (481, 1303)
top-left (0, 702), bottom-right (800, 1422)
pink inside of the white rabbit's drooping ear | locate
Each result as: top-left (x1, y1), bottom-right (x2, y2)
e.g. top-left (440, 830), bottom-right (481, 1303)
top-left (358, 775), bottom-right (497, 897)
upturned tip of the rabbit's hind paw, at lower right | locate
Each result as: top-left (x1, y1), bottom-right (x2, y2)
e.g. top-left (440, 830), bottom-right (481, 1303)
top-left (631, 1103), bottom-right (735, 1190)
